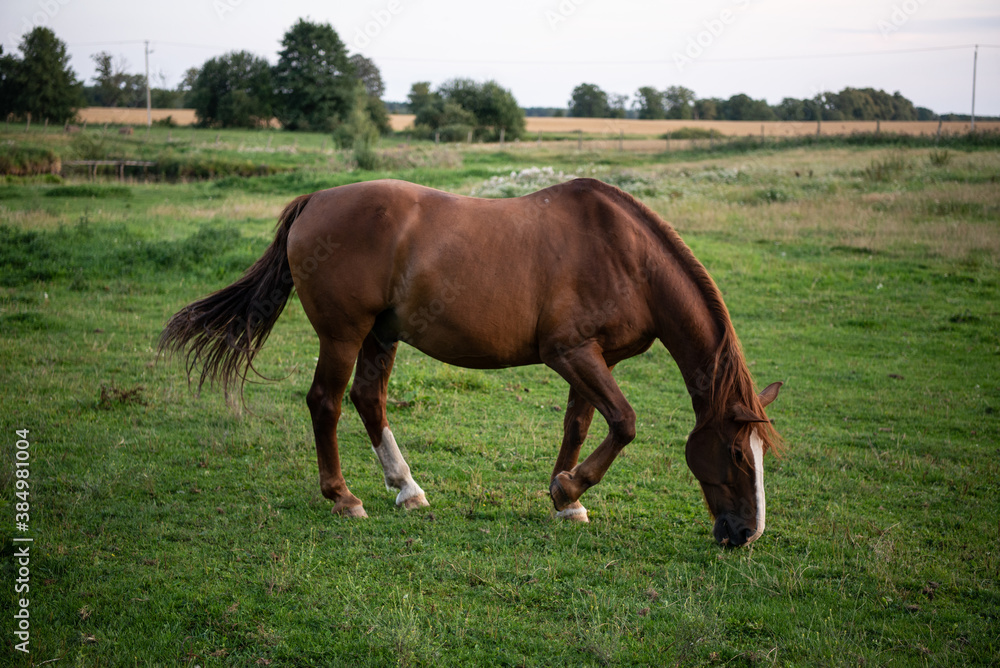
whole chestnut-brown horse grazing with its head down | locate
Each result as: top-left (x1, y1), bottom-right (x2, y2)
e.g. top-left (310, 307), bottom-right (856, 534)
top-left (160, 179), bottom-right (781, 545)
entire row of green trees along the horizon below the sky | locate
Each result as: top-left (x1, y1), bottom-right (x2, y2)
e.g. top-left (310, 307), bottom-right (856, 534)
top-left (0, 24), bottom-right (976, 137)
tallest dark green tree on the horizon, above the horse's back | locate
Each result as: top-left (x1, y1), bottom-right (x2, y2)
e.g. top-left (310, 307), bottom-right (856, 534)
top-left (274, 19), bottom-right (357, 130)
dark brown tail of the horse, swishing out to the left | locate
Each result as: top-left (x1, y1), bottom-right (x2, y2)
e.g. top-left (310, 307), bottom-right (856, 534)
top-left (159, 195), bottom-right (312, 395)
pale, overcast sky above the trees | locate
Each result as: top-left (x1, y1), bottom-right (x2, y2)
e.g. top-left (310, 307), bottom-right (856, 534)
top-left (0, 0), bottom-right (1000, 116)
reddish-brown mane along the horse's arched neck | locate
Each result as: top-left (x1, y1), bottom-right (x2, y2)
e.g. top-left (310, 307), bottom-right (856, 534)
top-left (595, 181), bottom-right (781, 452)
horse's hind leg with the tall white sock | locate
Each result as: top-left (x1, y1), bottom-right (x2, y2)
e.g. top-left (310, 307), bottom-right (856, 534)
top-left (351, 334), bottom-right (429, 509)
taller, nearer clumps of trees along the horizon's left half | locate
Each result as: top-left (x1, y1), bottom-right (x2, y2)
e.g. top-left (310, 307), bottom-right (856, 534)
top-left (0, 19), bottom-right (524, 145)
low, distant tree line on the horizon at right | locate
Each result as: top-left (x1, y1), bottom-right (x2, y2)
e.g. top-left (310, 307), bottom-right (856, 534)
top-left (569, 83), bottom-right (938, 122)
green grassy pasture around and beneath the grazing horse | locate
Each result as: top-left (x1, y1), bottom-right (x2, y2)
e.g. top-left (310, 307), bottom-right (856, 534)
top-left (0, 129), bottom-right (1000, 666)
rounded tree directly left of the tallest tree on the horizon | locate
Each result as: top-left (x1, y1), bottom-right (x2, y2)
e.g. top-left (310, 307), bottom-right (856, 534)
top-left (191, 51), bottom-right (274, 128)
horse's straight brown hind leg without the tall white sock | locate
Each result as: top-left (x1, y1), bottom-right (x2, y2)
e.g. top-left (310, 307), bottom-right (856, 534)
top-left (306, 339), bottom-right (367, 517)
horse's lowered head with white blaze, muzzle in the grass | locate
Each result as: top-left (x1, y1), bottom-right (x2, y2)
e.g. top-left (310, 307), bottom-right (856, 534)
top-left (686, 383), bottom-right (781, 546)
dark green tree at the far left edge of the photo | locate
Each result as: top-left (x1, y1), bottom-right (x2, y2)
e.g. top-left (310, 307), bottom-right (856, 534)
top-left (0, 27), bottom-right (85, 123)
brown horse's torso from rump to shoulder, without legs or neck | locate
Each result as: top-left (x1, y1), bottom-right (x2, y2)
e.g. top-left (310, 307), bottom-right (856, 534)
top-left (288, 181), bottom-right (660, 367)
